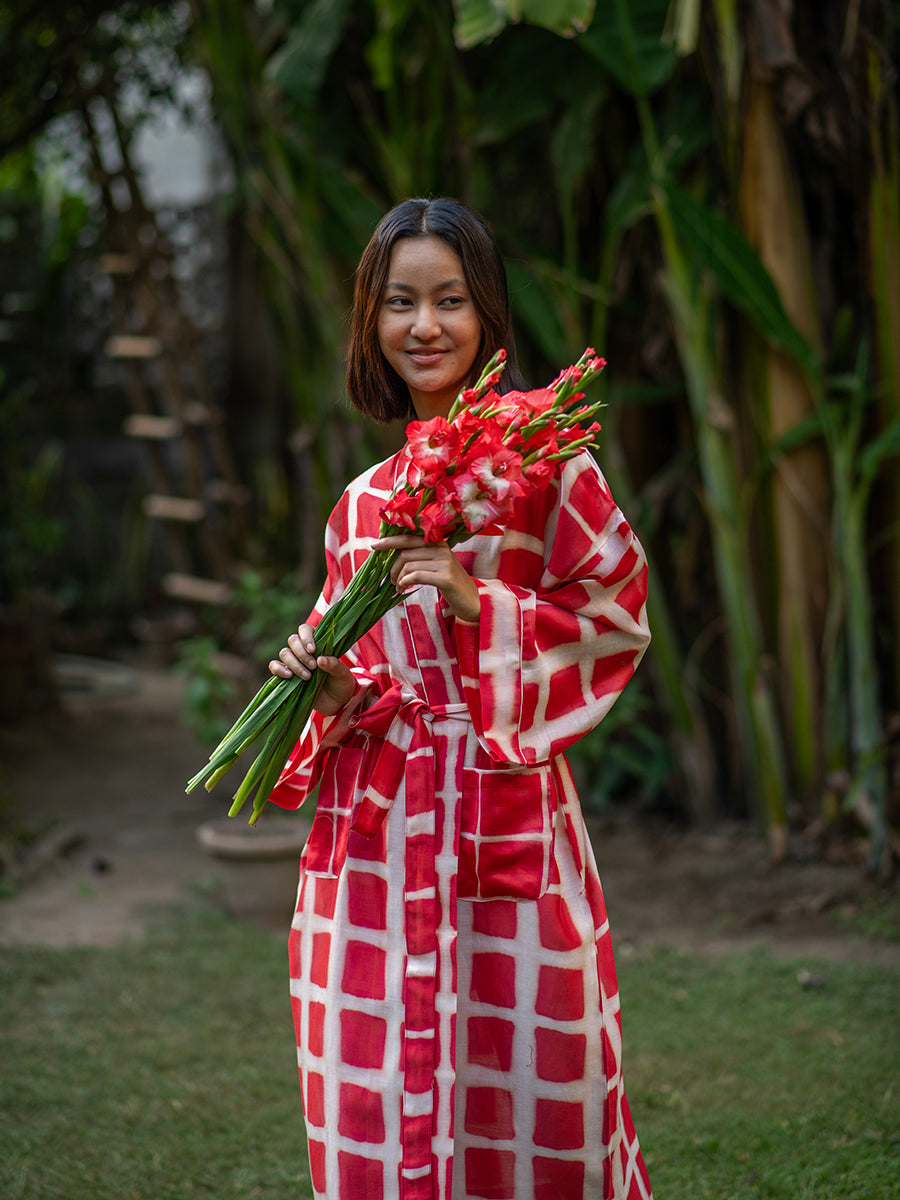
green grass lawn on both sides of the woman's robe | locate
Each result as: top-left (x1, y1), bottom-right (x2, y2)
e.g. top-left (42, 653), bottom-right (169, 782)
top-left (0, 916), bottom-right (900, 1200)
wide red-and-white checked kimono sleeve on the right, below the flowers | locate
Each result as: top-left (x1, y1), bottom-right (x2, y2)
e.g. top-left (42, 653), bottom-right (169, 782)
top-left (455, 454), bottom-right (650, 766)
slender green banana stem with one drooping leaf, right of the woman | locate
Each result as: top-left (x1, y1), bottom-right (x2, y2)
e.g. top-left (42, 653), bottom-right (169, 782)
top-left (458, 0), bottom-right (830, 857)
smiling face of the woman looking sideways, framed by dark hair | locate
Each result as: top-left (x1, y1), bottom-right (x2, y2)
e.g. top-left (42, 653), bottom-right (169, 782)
top-left (378, 236), bottom-right (481, 421)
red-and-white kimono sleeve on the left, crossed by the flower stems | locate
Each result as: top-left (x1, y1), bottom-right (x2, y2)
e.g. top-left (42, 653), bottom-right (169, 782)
top-left (269, 482), bottom-right (376, 809)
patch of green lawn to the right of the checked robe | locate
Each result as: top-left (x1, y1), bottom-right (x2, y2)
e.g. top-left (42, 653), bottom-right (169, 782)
top-left (619, 953), bottom-right (900, 1200)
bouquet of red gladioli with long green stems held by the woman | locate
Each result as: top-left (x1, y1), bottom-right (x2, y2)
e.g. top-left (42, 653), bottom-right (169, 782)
top-left (186, 349), bottom-right (606, 824)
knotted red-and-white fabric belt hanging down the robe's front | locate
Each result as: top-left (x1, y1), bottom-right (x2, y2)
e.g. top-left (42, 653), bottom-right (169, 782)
top-left (349, 684), bottom-right (472, 1200)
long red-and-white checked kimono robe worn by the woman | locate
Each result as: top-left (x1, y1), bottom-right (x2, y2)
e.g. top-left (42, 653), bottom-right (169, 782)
top-left (271, 452), bottom-right (650, 1200)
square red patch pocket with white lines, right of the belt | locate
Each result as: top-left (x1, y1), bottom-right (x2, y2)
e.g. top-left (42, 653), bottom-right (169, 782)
top-left (456, 766), bottom-right (556, 900)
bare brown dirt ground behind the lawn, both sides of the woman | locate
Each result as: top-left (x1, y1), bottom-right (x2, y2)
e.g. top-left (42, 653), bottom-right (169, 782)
top-left (0, 666), bottom-right (900, 962)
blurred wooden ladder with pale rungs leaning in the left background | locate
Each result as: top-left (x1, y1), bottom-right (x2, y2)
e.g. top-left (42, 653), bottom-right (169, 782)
top-left (82, 93), bottom-right (256, 605)
